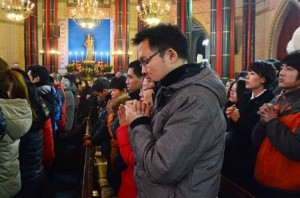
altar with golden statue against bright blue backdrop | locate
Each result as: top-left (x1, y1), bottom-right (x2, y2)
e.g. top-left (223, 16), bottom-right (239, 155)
top-left (61, 19), bottom-right (113, 76)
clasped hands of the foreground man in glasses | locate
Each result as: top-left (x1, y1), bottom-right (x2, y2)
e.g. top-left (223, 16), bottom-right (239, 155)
top-left (118, 100), bottom-right (152, 125)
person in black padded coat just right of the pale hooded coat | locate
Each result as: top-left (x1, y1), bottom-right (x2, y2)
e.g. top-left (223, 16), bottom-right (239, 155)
top-left (14, 69), bottom-right (46, 198)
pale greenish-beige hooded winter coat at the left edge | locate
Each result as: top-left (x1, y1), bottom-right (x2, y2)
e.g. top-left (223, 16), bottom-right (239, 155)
top-left (0, 99), bottom-right (32, 198)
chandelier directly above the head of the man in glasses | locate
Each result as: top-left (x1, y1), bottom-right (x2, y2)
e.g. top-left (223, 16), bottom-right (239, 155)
top-left (137, 0), bottom-right (170, 26)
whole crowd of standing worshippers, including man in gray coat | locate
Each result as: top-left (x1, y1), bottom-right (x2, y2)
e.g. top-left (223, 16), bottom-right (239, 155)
top-left (0, 25), bottom-right (300, 198)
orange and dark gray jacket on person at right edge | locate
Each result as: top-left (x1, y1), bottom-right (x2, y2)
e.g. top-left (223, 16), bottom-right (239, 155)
top-left (252, 89), bottom-right (300, 190)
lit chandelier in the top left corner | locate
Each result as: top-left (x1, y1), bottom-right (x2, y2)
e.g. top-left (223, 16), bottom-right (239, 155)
top-left (1, 0), bottom-right (34, 21)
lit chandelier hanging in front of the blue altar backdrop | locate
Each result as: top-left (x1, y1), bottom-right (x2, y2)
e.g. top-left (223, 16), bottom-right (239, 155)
top-left (71, 0), bottom-right (104, 28)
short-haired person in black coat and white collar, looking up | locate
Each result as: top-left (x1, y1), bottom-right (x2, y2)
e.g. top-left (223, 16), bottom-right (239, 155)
top-left (226, 61), bottom-right (275, 195)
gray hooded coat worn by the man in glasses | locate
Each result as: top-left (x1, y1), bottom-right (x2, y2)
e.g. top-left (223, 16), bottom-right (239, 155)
top-left (130, 65), bottom-right (226, 198)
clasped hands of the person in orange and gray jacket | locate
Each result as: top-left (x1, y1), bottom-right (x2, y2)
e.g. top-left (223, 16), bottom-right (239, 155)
top-left (257, 103), bottom-right (278, 123)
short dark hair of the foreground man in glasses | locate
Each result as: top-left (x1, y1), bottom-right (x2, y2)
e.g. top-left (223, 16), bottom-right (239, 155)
top-left (132, 24), bottom-right (188, 60)
